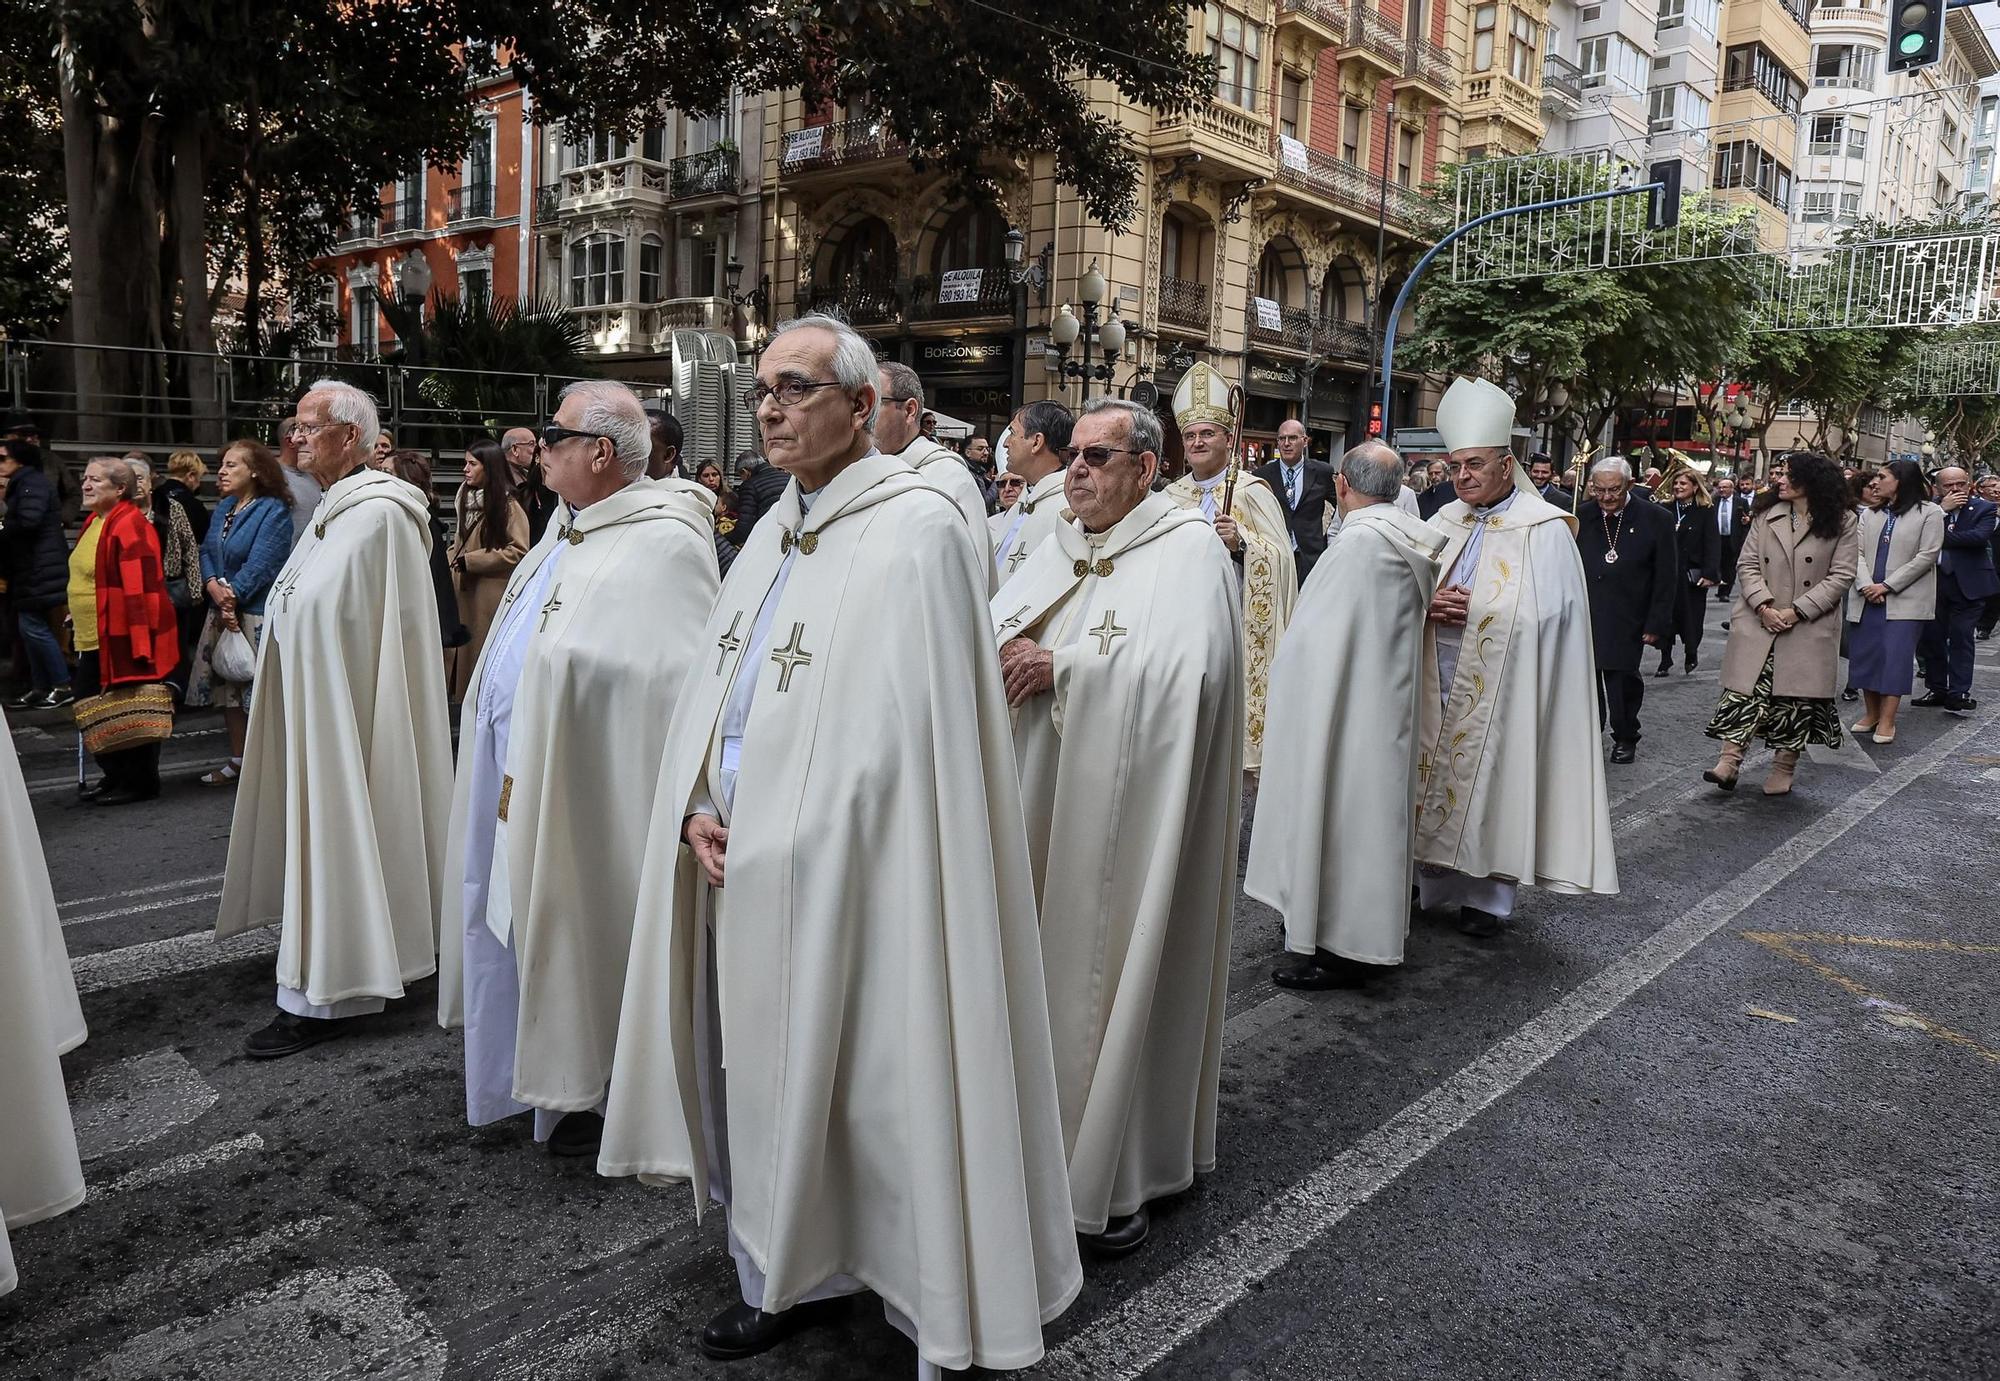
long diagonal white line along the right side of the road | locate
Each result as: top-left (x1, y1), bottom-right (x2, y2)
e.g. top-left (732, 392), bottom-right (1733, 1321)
top-left (1026, 713), bottom-right (2000, 1381)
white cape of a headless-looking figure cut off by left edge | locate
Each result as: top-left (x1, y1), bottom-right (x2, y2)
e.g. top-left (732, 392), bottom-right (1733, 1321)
top-left (0, 721), bottom-right (86, 1295)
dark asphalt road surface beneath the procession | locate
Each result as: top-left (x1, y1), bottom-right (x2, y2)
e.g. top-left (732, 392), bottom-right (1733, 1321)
top-left (0, 600), bottom-right (2000, 1381)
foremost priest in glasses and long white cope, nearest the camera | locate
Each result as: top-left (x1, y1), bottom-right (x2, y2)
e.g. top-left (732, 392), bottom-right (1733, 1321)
top-left (598, 316), bottom-right (1082, 1375)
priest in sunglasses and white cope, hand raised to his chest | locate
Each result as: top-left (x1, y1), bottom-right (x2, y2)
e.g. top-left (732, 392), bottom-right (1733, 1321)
top-left (992, 398), bottom-right (1242, 1257)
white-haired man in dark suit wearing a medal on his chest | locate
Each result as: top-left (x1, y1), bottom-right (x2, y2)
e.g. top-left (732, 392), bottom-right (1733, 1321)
top-left (1576, 456), bottom-right (1682, 763)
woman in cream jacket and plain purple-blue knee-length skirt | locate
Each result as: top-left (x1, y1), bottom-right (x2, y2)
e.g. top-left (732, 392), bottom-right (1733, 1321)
top-left (1848, 460), bottom-right (1944, 743)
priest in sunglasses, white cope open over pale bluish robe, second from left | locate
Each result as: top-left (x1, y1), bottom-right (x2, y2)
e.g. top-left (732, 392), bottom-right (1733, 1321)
top-left (438, 380), bottom-right (718, 1155)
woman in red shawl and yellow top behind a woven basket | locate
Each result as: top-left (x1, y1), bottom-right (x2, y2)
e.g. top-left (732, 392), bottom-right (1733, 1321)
top-left (70, 458), bottom-right (180, 805)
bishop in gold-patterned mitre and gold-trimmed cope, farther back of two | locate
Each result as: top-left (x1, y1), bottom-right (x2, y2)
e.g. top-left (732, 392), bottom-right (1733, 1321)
top-left (1164, 364), bottom-right (1298, 773)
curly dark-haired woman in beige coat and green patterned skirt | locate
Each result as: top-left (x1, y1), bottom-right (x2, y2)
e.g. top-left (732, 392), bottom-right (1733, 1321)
top-left (1702, 452), bottom-right (1860, 797)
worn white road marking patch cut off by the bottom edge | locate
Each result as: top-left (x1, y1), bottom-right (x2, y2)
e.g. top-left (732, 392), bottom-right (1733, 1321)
top-left (84, 1267), bottom-right (446, 1381)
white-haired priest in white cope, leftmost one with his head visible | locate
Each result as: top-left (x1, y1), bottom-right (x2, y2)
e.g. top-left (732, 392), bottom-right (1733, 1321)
top-left (216, 382), bottom-right (452, 1059)
